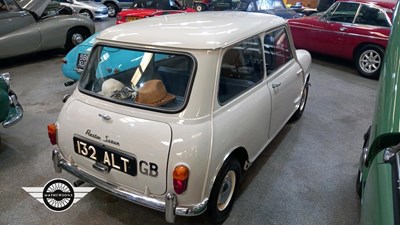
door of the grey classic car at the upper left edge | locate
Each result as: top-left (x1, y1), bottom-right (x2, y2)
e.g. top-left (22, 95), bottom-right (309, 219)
top-left (0, 0), bottom-right (41, 58)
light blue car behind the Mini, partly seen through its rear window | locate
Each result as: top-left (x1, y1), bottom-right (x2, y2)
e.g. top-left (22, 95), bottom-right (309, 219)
top-left (62, 32), bottom-right (166, 82)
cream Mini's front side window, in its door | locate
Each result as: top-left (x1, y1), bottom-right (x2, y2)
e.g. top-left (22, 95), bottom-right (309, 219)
top-left (264, 28), bottom-right (293, 75)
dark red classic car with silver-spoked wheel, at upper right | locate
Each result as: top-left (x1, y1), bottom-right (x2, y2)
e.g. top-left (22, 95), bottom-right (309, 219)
top-left (289, 0), bottom-right (397, 78)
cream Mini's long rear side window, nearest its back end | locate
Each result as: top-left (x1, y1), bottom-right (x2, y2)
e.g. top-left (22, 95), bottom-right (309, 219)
top-left (218, 37), bottom-right (264, 104)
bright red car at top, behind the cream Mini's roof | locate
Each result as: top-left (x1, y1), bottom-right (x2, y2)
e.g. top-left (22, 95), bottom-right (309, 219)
top-left (117, 0), bottom-right (196, 24)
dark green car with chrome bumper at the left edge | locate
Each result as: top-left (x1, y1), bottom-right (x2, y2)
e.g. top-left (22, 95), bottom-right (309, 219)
top-left (0, 73), bottom-right (23, 128)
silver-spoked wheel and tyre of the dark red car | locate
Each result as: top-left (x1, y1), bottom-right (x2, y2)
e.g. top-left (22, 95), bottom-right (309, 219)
top-left (354, 44), bottom-right (384, 79)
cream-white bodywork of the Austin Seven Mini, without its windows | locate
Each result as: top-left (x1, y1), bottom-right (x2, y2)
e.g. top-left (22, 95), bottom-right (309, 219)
top-left (51, 12), bottom-right (311, 221)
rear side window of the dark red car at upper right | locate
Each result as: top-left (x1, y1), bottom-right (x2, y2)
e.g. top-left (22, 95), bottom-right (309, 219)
top-left (355, 5), bottom-right (390, 27)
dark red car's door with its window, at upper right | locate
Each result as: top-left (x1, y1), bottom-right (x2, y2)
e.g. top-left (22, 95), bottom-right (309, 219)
top-left (308, 2), bottom-right (360, 57)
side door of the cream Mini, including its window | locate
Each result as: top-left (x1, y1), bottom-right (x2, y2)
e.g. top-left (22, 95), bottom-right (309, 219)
top-left (264, 27), bottom-right (304, 138)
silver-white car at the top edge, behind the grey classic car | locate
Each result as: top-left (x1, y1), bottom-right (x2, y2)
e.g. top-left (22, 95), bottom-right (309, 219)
top-left (59, 0), bottom-right (108, 19)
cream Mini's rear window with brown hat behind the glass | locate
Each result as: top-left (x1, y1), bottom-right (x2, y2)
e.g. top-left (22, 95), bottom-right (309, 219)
top-left (79, 46), bottom-right (194, 111)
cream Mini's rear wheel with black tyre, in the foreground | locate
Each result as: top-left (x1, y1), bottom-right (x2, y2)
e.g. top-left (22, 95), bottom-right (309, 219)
top-left (207, 158), bottom-right (241, 224)
